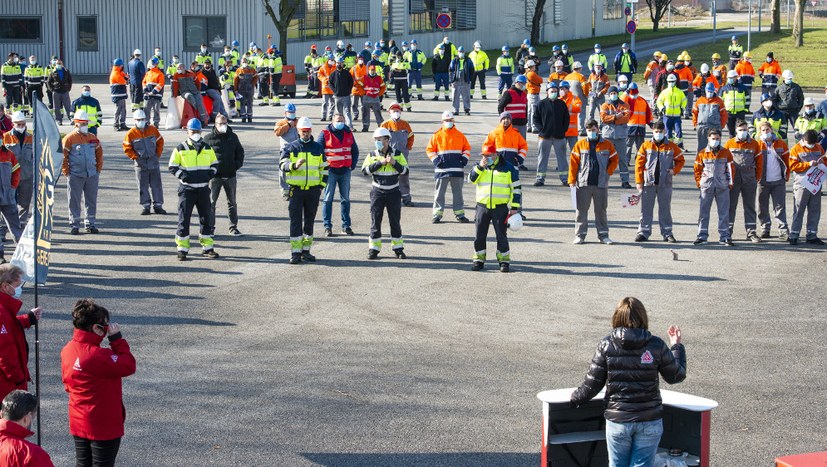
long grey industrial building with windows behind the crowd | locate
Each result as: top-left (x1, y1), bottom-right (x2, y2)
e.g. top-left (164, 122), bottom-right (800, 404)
top-left (0, 0), bottom-right (625, 74)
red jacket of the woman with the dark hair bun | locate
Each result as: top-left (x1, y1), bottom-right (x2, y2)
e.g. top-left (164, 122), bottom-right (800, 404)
top-left (60, 329), bottom-right (135, 441)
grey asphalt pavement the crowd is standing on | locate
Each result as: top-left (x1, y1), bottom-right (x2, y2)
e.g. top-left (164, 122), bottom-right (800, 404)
top-left (24, 70), bottom-right (827, 466)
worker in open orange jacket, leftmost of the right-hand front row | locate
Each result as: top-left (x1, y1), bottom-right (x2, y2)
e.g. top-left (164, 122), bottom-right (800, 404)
top-left (568, 120), bottom-right (618, 245)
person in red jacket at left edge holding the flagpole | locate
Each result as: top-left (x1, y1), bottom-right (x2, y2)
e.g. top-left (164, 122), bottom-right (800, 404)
top-left (0, 263), bottom-right (41, 404)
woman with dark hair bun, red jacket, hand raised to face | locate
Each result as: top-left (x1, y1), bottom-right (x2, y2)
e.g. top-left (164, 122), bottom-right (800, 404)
top-left (60, 298), bottom-right (135, 467)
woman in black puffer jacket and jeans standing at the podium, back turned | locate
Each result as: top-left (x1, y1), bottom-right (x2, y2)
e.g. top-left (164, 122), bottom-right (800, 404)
top-left (571, 297), bottom-right (686, 467)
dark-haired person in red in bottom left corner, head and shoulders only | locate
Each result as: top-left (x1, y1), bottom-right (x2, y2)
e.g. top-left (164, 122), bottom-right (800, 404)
top-left (0, 389), bottom-right (54, 467)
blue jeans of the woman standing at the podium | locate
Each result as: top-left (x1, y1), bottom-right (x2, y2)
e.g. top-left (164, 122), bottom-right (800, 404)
top-left (606, 420), bottom-right (663, 467)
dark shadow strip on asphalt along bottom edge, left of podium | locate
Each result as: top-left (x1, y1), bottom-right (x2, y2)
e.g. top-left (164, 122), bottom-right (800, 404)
top-left (300, 452), bottom-right (540, 467)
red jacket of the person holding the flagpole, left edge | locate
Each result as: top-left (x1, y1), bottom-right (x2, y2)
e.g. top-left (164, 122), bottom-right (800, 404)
top-left (0, 292), bottom-right (34, 400)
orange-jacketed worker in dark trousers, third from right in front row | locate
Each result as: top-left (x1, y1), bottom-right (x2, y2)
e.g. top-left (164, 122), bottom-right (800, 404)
top-left (724, 120), bottom-right (764, 243)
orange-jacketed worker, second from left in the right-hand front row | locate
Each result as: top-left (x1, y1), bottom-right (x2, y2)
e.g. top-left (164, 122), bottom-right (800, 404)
top-left (635, 120), bottom-right (685, 243)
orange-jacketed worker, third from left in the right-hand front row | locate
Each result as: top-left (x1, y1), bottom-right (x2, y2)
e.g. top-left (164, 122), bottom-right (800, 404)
top-left (694, 128), bottom-right (736, 246)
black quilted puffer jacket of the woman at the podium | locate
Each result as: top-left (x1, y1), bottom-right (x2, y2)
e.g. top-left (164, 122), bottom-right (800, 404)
top-left (571, 328), bottom-right (686, 423)
